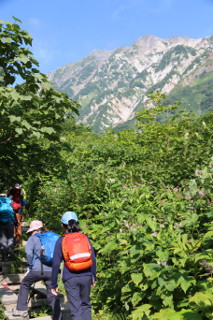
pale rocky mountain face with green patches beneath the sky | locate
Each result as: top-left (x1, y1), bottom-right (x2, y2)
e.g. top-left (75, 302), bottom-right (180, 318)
top-left (47, 35), bottom-right (213, 132)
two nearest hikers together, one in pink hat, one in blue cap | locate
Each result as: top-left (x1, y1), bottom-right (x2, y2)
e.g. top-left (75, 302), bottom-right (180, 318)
top-left (12, 211), bottom-right (96, 320)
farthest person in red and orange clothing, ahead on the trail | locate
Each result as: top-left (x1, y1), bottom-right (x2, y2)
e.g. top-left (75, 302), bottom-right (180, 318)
top-left (8, 183), bottom-right (24, 245)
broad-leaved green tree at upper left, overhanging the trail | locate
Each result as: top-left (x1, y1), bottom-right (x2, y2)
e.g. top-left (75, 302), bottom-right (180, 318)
top-left (0, 18), bottom-right (78, 186)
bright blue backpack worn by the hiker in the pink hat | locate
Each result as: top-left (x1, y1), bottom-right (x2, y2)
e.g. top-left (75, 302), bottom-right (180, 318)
top-left (35, 231), bottom-right (59, 266)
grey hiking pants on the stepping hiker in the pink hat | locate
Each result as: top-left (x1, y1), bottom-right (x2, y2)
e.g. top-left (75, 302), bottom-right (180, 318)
top-left (16, 271), bottom-right (62, 320)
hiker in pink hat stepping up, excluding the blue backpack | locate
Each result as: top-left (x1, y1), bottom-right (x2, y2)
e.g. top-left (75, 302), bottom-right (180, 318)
top-left (12, 220), bottom-right (62, 320)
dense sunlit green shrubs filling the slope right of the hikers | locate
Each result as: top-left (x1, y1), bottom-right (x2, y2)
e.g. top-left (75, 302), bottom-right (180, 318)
top-left (31, 92), bottom-right (213, 320)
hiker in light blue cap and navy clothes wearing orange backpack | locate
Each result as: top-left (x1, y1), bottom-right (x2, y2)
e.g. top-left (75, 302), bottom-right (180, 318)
top-left (52, 211), bottom-right (96, 320)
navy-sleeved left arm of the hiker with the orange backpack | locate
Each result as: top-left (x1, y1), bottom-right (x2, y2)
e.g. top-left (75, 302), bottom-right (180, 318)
top-left (51, 238), bottom-right (63, 288)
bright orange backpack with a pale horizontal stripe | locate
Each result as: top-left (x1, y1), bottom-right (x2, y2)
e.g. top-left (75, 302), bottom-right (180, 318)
top-left (62, 232), bottom-right (92, 272)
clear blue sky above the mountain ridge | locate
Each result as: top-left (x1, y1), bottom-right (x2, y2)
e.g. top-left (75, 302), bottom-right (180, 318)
top-left (0, 0), bottom-right (213, 73)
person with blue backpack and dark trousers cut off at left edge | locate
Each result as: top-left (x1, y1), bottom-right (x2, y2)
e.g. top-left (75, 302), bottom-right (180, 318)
top-left (0, 193), bottom-right (15, 261)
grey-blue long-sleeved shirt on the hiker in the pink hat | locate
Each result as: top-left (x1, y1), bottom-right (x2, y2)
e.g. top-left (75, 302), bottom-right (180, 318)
top-left (25, 235), bottom-right (52, 272)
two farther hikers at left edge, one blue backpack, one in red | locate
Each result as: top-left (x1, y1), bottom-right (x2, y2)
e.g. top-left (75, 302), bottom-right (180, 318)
top-left (0, 183), bottom-right (26, 261)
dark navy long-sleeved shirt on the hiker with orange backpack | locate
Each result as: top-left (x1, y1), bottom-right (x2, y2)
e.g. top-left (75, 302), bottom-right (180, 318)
top-left (52, 232), bottom-right (96, 289)
